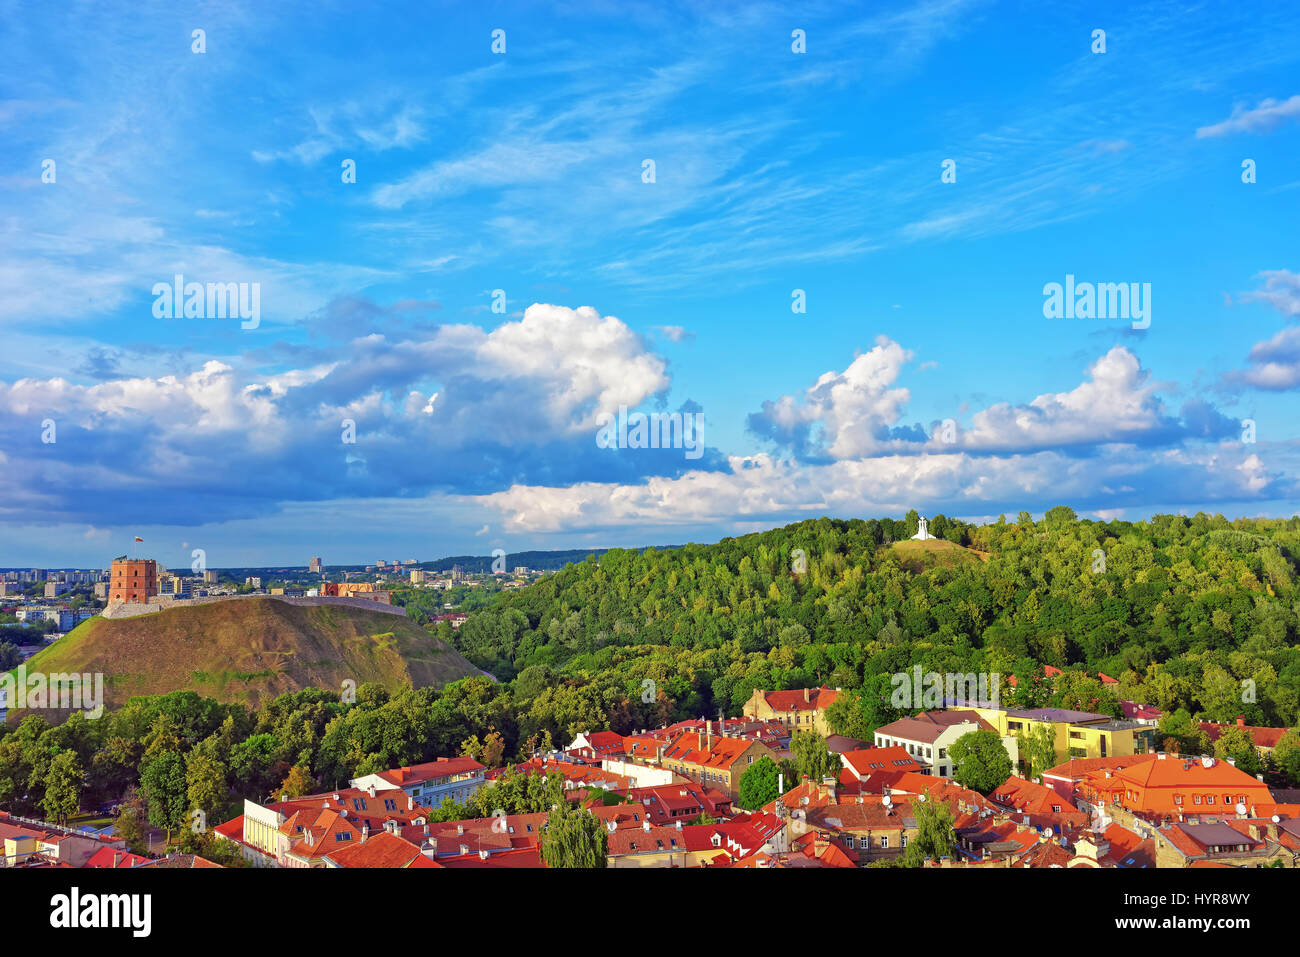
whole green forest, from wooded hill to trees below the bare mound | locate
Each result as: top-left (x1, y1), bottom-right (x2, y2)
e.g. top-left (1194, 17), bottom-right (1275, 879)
top-left (0, 507), bottom-right (1300, 833)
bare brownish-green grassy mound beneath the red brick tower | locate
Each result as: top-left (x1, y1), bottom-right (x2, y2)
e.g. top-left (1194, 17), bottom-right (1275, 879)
top-left (13, 598), bottom-right (482, 709)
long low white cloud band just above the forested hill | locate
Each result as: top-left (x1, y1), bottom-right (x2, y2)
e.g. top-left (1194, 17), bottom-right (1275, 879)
top-left (480, 445), bottom-right (1295, 533)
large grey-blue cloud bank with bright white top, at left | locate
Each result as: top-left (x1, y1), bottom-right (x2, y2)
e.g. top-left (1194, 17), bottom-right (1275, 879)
top-left (0, 303), bottom-right (719, 524)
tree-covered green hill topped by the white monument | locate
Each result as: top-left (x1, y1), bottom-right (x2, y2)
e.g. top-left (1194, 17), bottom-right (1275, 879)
top-left (443, 507), bottom-right (1300, 729)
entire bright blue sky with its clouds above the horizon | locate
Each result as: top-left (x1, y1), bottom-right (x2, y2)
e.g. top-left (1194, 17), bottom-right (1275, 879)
top-left (0, 0), bottom-right (1300, 567)
